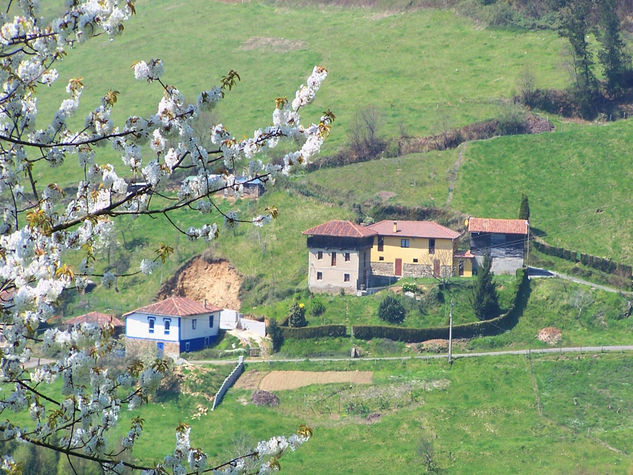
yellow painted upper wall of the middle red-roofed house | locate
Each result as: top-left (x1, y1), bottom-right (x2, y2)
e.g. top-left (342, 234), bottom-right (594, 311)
top-left (371, 236), bottom-right (454, 267)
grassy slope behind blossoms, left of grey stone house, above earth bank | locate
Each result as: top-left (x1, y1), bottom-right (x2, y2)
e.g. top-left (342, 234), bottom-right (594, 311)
top-left (61, 191), bottom-right (350, 316)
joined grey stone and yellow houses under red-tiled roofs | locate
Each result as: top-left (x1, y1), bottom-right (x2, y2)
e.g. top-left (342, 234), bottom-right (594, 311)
top-left (303, 220), bottom-right (475, 293)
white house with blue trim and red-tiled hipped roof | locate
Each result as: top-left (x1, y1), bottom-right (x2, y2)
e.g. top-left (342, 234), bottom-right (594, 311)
top-left (123, 297), bottom-right (222, 357)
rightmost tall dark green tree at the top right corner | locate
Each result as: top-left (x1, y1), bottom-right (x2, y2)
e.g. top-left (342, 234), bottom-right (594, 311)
top-left (597, 0), bottom-right (631, 94)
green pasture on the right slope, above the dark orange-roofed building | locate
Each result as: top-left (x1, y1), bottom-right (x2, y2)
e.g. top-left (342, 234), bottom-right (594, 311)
top-left (452, 120), bottom-right (633, 264)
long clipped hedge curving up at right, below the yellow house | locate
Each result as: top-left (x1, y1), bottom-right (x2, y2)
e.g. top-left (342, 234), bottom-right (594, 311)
top-left (352, 269), bottom-right (530, 343)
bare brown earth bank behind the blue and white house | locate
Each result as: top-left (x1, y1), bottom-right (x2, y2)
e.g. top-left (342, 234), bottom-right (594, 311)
top-left (157, 255), bottom-right (242, 310)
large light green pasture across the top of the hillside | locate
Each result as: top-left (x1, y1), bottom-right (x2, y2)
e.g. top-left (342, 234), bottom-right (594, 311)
top-left (30, 0), bottom-right (568, 190)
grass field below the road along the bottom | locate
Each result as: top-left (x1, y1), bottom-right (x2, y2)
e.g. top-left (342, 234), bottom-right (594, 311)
top-left (102, 355), bottom-right (633, 473)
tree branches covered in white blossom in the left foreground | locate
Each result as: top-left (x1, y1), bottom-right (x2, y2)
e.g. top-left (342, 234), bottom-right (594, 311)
top-left (0, 0), bottom-right (334, 473)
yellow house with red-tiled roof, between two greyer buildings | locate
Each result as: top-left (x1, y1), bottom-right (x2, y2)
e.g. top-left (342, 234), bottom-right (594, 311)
top-left (368, 220), bottom-right (462, 277)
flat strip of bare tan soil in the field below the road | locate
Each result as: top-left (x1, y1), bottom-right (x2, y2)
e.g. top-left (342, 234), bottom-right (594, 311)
top-left (259, 371), bottom-right (373, 391)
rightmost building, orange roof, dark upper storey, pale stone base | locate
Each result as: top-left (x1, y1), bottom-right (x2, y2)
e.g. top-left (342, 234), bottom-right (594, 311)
top-left (468, 218), bottom-right (530, 274)
